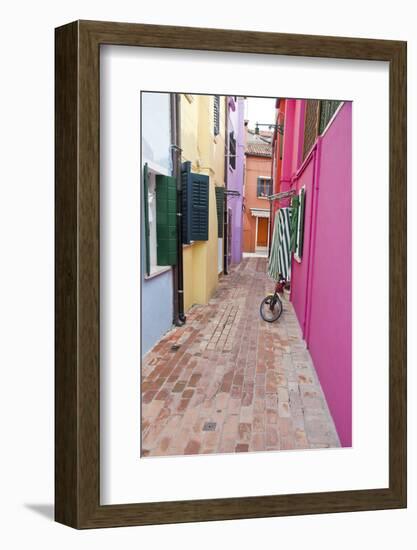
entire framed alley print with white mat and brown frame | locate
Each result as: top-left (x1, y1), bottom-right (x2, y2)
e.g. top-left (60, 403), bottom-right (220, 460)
top-left (55, 21), bottom-right (406, 528)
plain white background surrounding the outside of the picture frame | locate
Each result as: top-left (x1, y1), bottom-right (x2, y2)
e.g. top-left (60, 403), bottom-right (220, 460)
top-left (0, 0), bottom-right (417, 550)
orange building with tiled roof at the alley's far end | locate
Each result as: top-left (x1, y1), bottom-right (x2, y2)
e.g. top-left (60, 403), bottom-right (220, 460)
top-left (243, 129), bottom-right (272, 254)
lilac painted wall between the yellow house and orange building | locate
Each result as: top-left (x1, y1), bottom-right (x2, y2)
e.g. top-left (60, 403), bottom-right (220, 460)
top-left (227, 97), bottom-right (245, 264)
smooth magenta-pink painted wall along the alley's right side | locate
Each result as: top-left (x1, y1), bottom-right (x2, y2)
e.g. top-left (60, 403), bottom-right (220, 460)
top-left (291, 103), bottom-right (352, 447)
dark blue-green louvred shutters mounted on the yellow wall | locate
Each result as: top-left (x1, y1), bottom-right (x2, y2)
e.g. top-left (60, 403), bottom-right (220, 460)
top-left (181, 162), bottom-right (209, 244)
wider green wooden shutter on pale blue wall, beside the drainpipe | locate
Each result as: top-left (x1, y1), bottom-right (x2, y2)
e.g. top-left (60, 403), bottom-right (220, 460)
top-left (156, 175), bottom-right (177, 265)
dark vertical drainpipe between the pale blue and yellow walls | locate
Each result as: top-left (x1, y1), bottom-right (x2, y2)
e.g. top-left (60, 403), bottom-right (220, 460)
top-left (170, 94), bottom-right (186, 326)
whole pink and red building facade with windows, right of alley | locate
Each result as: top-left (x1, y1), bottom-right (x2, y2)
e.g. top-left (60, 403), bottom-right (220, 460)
top-left (274, 99), bottom-right (352, 447)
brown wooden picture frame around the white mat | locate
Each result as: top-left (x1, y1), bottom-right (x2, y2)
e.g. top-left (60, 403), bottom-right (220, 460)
top-left (55, 21), bottom-right (406, 528)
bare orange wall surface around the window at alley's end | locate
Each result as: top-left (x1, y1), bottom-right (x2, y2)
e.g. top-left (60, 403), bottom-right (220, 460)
top-left (243, 155), bottom-right (271, 252)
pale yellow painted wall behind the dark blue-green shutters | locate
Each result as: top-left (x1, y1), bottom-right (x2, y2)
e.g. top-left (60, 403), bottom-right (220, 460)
top-left (181, 94), bottom-right (226, 311)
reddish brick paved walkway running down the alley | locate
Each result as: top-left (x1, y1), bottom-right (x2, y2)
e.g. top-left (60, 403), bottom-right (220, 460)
top-left (142, 258), bottom-right (339, 456)
